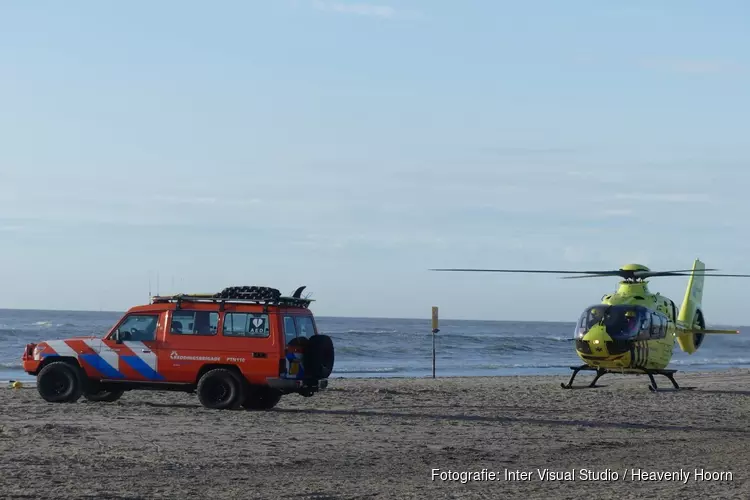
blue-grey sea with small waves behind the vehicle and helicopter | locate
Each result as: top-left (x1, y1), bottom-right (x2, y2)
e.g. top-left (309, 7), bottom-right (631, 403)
top-left (0, 309), bottom-right (750, 382)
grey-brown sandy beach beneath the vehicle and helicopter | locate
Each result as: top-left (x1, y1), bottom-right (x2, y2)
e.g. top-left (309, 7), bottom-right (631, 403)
top-left (0, 370), bottom-right (750, 500)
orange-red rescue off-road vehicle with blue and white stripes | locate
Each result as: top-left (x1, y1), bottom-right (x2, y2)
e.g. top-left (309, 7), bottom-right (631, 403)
top-left (22, 286), bottom-right (334, 410)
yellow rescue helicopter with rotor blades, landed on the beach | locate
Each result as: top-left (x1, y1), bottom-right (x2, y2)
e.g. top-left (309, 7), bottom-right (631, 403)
top-left (431, 259), bottom-right (750, 392)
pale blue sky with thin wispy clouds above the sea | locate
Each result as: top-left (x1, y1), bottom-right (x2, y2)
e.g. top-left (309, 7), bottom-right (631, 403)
top-left (0, 0), bottom-right (750, 324)
